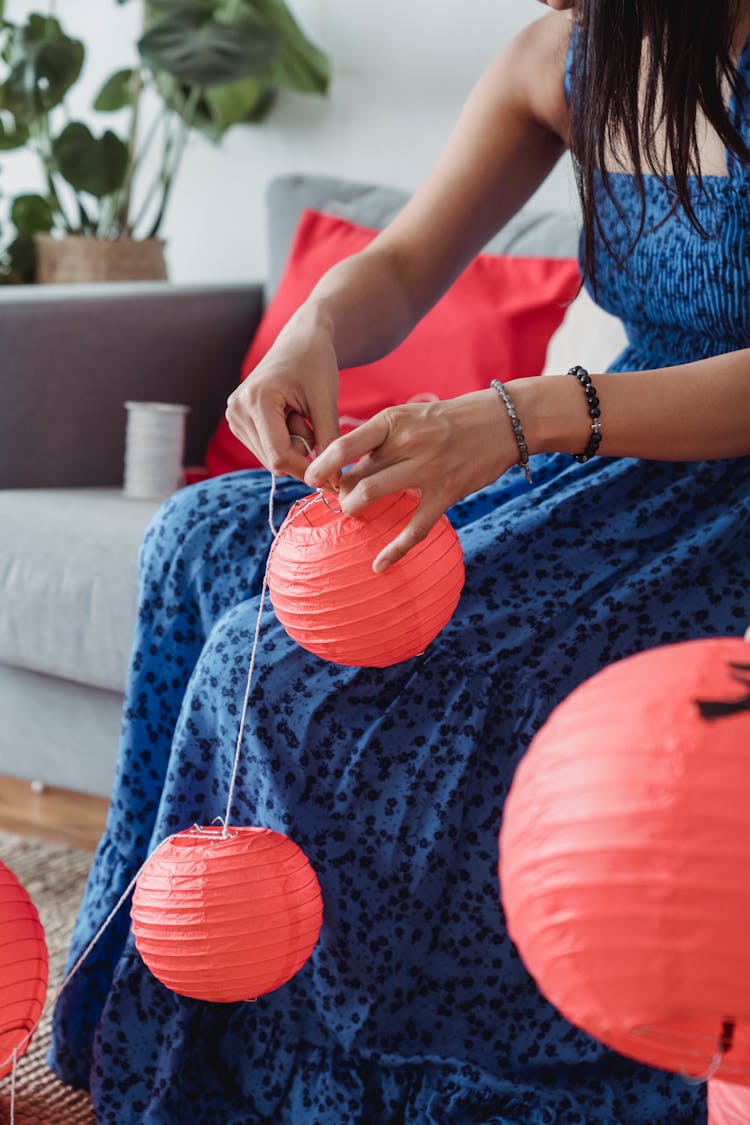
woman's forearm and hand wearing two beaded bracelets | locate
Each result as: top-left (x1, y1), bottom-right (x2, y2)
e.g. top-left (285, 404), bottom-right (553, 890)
top-left (305, 349), bottom-right (750, 570)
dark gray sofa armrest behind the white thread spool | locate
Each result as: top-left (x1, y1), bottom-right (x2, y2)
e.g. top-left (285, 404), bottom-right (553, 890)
top-left (0, 281), bottom-right (263, 488)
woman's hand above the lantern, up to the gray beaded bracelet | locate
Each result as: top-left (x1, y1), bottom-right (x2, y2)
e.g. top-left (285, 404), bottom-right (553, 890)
top-left (305, 390), bottom-right (518, 573)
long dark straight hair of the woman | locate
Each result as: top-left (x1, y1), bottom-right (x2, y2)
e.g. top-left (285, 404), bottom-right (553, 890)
top-left (570, 0), bottom-right (750, 286)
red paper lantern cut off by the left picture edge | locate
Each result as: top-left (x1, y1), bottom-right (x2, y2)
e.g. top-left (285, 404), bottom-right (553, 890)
top-left (0, 863), bottom-right (47, 1078)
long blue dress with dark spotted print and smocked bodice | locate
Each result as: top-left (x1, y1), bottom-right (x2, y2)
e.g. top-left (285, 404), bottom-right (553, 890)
top-left (51, 37), bottom-right (750, 1125)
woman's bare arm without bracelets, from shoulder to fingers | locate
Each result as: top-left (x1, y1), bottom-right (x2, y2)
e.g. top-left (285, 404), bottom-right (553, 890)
top-left (227, 14), bottom-right (570, 478)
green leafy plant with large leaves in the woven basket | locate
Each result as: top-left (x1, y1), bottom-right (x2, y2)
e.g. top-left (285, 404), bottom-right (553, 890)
top-left (0, 0), bottom-right (329, 282)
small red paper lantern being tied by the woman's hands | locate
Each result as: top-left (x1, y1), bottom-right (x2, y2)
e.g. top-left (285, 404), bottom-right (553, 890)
top-left (269, 492), bottom-right (463, 668)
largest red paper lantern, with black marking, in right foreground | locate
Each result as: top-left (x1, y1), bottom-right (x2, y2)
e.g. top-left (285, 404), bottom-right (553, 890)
top-left (499, 638), bottom-right (750, 1080)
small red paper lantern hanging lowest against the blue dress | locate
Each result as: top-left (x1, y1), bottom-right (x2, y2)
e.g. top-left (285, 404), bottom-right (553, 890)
top-left (130, 827), bottom-right (323, 1002)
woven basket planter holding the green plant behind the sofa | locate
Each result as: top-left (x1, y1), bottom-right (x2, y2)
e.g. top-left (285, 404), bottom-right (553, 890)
top-left (36, 234), bottom-right (166, 285)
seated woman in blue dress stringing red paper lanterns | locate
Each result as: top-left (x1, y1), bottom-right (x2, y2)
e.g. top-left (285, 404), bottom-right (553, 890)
top-left (49, 0), bottom-right (750, 1125)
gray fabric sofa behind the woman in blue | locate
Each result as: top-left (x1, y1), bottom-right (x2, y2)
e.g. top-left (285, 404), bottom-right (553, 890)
top-left (0, 176), bottom-right (578, 794)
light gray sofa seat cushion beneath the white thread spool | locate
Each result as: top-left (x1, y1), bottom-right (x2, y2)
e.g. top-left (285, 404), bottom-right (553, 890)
top-left (0, 488), bottom-right (157, 692)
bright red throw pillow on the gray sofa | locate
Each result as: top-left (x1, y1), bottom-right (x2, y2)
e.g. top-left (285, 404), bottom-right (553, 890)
top-left (206, 210), bottom-right (580, 476)
